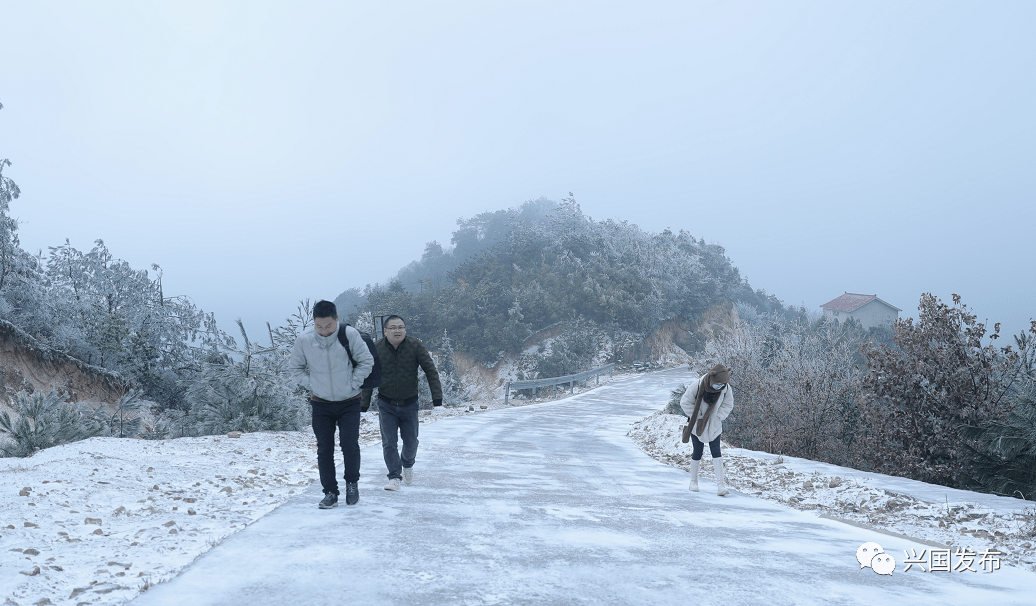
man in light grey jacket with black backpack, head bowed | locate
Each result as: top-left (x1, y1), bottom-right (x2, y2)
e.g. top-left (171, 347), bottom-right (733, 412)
top-left (288, 300), bottom-right (374, 510)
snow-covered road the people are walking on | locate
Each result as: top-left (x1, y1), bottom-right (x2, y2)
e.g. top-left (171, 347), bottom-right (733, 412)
top-left (127, 371), bottom-right (1036, 606)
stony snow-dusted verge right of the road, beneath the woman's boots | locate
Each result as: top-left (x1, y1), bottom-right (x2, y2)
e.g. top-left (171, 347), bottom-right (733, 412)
top-left (628, 409), bottom-right (1036, 571)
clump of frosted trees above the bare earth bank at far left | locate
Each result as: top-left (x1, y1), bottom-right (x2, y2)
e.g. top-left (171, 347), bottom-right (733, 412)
top-left (0, 106), bottom-right (228, 416)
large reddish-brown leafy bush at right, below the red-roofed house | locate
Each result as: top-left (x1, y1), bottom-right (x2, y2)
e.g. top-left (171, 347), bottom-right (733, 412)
top-left (864, 293), bottom-right (1023, 486)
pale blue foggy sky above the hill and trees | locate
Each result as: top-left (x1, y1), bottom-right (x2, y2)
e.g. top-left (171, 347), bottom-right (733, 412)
top-left (0, 0), bottom-right (1036, 334)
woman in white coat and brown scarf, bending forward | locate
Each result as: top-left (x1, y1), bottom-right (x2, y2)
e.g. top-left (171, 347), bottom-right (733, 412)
top-left (680, 364), bottom-right (733, 496)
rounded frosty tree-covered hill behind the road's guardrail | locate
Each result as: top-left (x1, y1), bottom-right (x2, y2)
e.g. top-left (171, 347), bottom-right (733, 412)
top-left (352, 196), bottom-right (783, 364)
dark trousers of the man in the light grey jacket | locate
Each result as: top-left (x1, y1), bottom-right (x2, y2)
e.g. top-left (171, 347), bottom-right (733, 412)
top-left (310, 398), bottom-right (359, 494)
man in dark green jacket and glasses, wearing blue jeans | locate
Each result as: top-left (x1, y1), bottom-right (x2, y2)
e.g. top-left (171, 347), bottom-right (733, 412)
top-left (363, 316), bottom-right (442, 490)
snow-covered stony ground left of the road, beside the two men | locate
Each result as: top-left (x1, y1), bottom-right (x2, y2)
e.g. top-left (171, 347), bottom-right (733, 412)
top-left (0, 376), bottom-right (607, 606)
